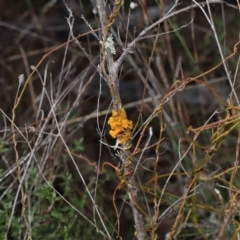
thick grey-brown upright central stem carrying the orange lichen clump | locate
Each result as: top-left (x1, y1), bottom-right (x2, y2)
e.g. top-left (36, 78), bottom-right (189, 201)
top-left (96, 0), bottom-right (148, 240)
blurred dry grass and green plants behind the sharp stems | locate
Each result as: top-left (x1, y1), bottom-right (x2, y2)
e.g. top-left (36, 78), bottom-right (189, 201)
top-left (0, 0), bottom-right (240, 240)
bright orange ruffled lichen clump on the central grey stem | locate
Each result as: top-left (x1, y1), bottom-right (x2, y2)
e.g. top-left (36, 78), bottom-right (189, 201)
top-left (108, 108), bottom-right (133, 144)
